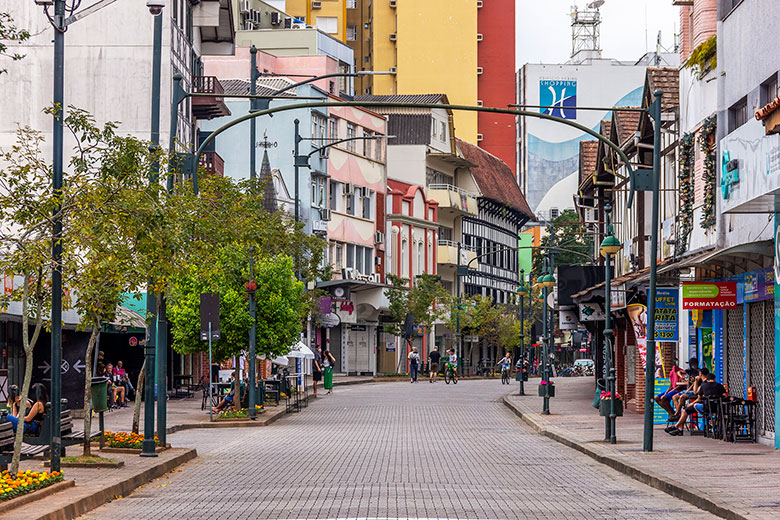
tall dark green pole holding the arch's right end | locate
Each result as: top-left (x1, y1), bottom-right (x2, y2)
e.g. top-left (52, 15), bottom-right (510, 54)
top-left (642, 90), bottom-right (663, 451)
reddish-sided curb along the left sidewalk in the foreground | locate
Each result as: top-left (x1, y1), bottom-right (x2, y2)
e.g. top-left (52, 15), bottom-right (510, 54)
top-left (29, 449), bottom-right (198, 520)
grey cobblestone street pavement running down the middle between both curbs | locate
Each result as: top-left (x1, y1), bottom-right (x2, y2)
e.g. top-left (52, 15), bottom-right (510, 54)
top-left (77, 380), bottom-right (711, 520)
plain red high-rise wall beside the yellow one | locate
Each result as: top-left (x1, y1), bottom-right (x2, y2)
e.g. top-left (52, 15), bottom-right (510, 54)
top-left (472, 0), bottom-right (517, 176)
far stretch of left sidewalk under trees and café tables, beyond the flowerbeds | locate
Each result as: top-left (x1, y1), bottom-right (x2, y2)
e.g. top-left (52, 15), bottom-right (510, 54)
top-left (98, 375), bottom-right (374, 433)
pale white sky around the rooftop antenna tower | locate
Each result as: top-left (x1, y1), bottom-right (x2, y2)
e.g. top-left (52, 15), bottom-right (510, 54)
top-left (515, 0), bottom-right (680, 68)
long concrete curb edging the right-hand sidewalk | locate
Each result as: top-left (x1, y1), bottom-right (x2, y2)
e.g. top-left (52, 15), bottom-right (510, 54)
top-left (502, 395), bottom-right (755, 520)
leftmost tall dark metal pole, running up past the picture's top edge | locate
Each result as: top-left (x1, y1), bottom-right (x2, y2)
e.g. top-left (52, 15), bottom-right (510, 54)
top-left (50, 0), bottom-right (65, 471)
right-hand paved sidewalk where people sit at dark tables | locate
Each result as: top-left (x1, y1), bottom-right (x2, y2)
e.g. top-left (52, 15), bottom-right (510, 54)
top-left (504, 377), bottom-right (780, 520)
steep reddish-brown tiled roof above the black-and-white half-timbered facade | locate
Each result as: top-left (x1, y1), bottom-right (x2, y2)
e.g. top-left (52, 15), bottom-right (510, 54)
top-left (457, 139), bottom-right (536, 220)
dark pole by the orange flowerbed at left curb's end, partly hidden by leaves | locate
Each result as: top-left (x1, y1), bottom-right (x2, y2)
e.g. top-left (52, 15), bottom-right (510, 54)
top-left (141, 9), bottom-right (162, 457)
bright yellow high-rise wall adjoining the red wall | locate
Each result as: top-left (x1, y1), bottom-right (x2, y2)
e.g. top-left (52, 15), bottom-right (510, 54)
top-left (370, 0), bottom-right (478, 143)
